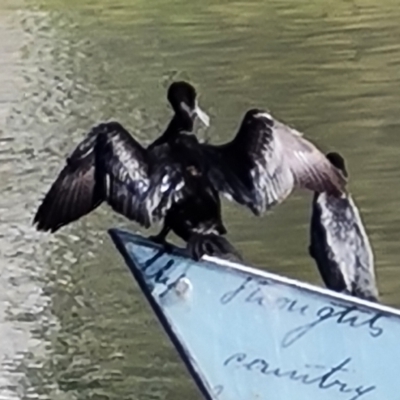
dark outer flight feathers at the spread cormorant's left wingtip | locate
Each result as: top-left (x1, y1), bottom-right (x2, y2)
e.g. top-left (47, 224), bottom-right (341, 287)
top-left (33, 128), bottom-right (104, 232)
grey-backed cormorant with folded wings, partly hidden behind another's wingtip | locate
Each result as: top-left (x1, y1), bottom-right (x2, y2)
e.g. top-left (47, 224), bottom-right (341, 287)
top-left (309, 153), bottom-right (378, 301)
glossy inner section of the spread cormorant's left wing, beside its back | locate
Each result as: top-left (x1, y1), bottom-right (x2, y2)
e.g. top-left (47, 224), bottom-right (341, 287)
top-left (96, 123), bottom-right (182, 228)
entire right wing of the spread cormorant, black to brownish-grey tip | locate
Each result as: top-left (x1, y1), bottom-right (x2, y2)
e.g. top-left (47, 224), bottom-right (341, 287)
top-left (202, 109), bottom-right (346, 215)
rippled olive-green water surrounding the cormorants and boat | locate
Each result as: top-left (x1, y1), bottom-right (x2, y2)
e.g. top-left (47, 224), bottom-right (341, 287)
top-left (0, 0), bottom-right (400, 400)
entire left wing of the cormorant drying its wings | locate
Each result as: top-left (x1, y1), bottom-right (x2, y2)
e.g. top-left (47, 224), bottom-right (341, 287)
top-left (34, 122), bottom-right (182, 232)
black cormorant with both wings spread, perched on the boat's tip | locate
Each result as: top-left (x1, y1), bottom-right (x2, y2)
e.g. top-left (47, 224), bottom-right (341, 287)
top-left (34, 97), bottom-right (345, 260)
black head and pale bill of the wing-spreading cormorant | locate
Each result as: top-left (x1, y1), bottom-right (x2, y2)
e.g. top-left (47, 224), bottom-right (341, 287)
top-left (167, 81), bottom-right (210, 127)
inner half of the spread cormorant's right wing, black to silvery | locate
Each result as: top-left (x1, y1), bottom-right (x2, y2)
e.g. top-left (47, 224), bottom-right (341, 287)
top-left (203, 114), bottom-right (294, 215)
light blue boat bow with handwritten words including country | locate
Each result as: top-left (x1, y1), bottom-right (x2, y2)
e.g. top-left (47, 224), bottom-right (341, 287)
top-left (110, 229), bottom-right (400, 400)
